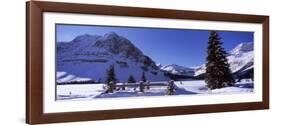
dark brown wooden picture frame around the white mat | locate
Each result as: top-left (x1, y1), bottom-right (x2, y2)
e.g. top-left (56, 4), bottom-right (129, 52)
top-left (26, 1), bottom-right (269, 124)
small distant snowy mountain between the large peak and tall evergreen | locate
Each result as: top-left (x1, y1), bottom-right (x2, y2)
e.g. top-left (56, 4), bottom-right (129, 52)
top-left (161, 64), bottom-right (194, 76)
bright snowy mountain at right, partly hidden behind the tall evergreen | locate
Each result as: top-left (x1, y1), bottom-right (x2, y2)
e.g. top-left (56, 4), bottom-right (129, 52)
top-left (195, 42), bottom-right (254, 76)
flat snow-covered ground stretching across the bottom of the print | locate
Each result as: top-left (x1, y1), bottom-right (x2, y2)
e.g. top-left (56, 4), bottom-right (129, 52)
top-left (57, 80), bottom-right (254, 100)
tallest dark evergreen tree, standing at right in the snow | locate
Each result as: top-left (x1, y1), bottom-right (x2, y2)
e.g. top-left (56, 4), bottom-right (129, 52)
top-left (205, 31), bottom-right (234, 89)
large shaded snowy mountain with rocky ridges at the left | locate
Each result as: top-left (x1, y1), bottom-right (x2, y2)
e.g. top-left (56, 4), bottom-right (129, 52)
top-left (56, 32), bottom-right (167, 82)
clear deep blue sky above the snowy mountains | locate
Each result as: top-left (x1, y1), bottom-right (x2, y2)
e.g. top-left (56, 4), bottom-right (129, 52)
top-left (56, 24), bottom-right (254, 67)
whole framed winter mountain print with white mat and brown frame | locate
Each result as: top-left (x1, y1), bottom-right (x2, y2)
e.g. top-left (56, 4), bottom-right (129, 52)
top-left (26, 1), bottom-right (269, 124)
